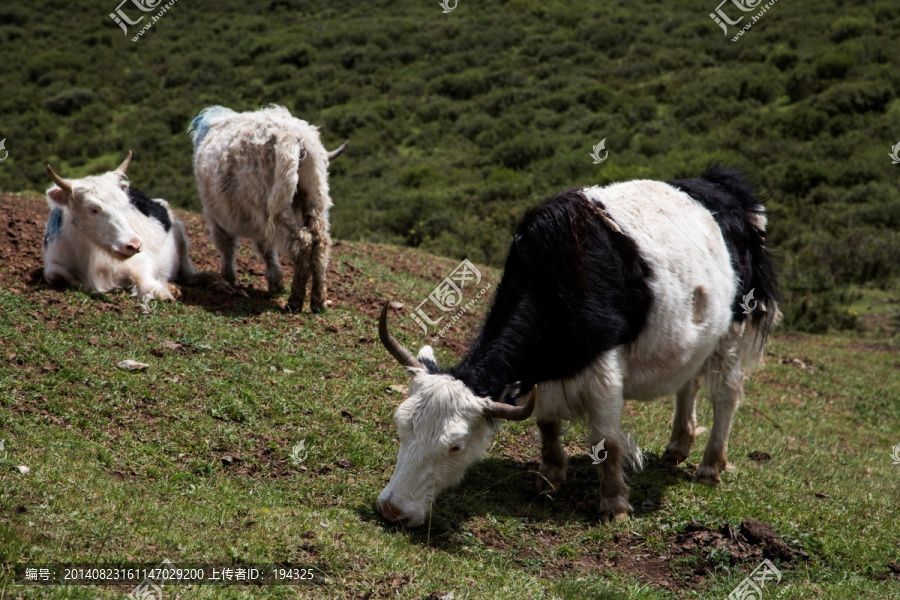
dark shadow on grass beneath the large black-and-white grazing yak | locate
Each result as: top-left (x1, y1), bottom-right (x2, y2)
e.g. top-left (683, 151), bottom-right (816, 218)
top-left (357, 454), bottom-right (693, 550)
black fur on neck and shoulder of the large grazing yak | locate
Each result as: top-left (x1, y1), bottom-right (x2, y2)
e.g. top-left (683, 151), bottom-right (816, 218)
top-left (450, 189), bottom-right (652, 399)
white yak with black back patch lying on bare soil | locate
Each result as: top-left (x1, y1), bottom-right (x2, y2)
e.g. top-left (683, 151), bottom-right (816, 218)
top-left (43, 151), bottom-right (198, 300)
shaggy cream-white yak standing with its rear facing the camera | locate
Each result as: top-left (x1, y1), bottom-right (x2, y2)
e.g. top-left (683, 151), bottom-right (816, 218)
top-left (188, 105), bottom-right (347, 312)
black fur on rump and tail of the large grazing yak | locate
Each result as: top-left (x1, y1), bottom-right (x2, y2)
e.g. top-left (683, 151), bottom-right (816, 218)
top-left (666, 164), bottom-right (779, 339)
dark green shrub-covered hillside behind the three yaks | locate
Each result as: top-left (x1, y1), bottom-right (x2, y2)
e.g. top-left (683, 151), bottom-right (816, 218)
top-left (0, 0), bottom-right (900, 331)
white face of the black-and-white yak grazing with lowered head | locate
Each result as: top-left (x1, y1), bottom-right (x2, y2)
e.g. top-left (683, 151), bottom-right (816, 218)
top-left (378, 346), bottom-right (493, 527)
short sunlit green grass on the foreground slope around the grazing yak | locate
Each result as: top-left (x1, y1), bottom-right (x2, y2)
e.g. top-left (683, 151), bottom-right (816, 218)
top-left (0, 242), bottom-right (900, 600)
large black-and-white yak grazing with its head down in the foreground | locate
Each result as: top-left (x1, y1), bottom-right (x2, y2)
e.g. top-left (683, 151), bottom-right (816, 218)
top-left (378, 165), bottom-right (780, 526)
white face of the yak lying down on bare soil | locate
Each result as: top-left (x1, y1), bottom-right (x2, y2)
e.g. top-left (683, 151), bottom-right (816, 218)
top-left (47, 171), bottom-right (141, 259)
